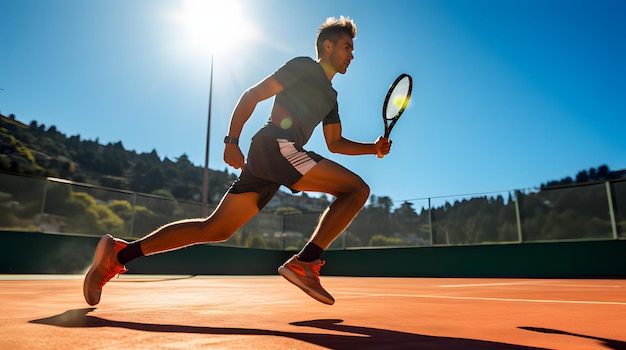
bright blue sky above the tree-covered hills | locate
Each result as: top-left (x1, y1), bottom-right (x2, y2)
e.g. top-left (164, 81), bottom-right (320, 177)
top-left (0, 0), bottom-right (626, 205)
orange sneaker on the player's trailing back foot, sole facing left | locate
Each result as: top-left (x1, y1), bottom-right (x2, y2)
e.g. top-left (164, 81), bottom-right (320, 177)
top-left (83, 235), bottom-right (128, 305)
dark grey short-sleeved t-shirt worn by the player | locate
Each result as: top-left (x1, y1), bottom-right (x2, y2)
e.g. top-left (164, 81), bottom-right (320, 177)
top-left (257, 57), bottom-right (341, 146)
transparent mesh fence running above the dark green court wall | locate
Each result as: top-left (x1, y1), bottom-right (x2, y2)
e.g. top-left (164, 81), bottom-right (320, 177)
top-left (0, 173), bottom-right (626, 250)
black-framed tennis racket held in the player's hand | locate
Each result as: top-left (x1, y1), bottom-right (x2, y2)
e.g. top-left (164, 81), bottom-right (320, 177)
top-left (378, 73), bottom-right (413, 158)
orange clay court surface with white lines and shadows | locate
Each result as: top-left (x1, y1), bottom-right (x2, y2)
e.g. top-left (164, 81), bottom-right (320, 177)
top-left (0, 275), bottom-right (626, 350)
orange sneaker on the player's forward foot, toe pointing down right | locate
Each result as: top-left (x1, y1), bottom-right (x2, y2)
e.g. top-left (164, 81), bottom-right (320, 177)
top-left (278, 255), bottom-right (335, 305)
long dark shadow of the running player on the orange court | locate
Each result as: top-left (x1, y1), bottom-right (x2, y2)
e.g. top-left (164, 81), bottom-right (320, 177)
top-left (29, 308), bottom-right (539, 350)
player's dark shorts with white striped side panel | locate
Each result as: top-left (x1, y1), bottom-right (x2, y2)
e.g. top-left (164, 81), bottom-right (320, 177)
top-left (228, 136), bottom-right (324, 210)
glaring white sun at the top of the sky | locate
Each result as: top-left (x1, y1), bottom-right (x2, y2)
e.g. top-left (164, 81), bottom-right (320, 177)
top-left (176, 0), bottom-right (255, 54)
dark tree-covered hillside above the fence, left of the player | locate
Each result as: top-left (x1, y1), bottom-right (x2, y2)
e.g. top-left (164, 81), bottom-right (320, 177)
top-left (0, 115), bottom-right (236, 203)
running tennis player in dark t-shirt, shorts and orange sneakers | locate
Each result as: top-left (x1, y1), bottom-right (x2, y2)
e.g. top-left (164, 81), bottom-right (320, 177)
top-left (83, 17), bottom-right (391, 305)
